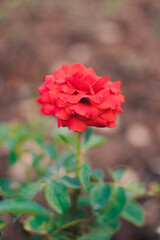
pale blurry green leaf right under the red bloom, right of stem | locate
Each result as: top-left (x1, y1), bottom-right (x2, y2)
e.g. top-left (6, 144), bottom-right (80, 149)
top-left (84, 134), bottom-right (106, 150)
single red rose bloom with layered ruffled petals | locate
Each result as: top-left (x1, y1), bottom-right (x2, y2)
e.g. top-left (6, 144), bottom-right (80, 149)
top-left (37, 63), bottom-right (124, 132)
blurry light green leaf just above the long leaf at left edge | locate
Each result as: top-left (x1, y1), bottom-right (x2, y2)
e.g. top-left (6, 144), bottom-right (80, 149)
top-left (18, 182), bottom-right (41, 199)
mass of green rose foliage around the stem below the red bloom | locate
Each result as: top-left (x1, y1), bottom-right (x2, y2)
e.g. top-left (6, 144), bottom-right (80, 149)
top-left (0, 121), bottom-right (146, 240)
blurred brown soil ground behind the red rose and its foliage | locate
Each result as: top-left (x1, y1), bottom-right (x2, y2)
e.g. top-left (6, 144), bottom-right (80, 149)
top-left (0, 0), bottom-right (160, 240)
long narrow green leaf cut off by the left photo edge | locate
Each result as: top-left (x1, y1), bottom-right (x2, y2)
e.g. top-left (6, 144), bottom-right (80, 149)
top-left (0, 199), bottom-right (50, 216)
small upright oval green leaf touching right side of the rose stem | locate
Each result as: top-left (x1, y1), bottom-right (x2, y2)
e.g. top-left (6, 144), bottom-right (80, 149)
top-left (79, 163), bottom-right (91, 186)
